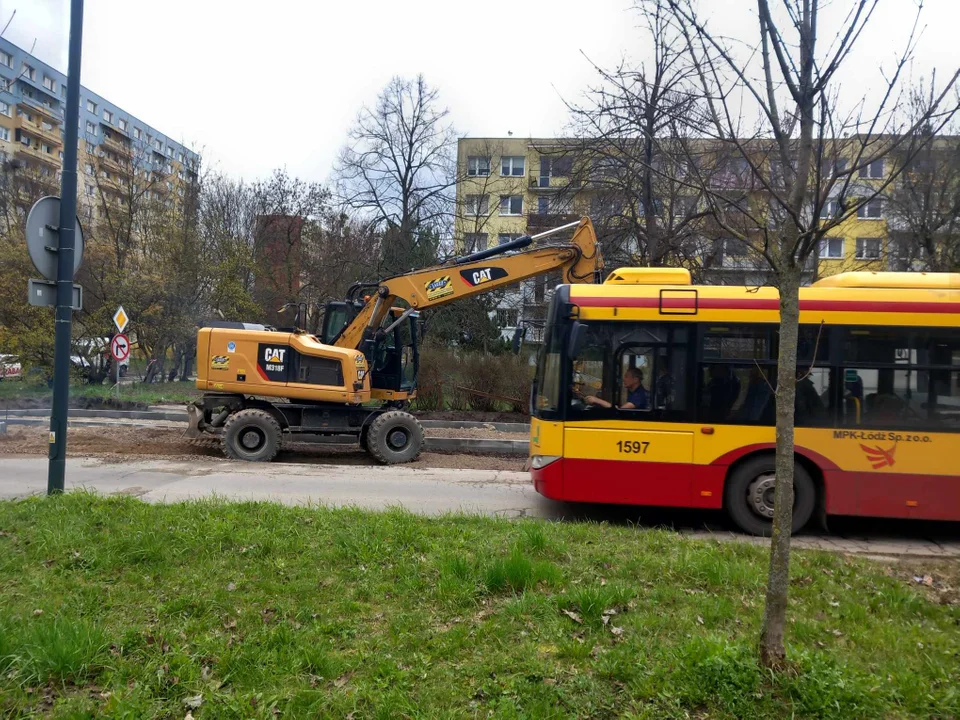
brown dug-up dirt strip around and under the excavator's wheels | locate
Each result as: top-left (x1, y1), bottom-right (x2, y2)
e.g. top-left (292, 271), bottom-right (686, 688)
top-left (0, 425), bottom-right (527, 471)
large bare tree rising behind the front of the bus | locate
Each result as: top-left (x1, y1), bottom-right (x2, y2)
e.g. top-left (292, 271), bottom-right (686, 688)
top-left (556, 3), bottom-right (706, 266)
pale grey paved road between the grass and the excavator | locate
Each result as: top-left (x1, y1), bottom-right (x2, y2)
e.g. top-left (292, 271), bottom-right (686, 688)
top-left (0, 456), bottom-right (960, 560)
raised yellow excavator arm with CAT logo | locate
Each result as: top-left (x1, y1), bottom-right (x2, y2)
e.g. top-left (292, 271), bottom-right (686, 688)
top-left (334, 217), bottom-right (603, 348)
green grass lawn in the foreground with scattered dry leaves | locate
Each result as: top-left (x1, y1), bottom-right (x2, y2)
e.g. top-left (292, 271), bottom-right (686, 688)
top-left (0, 493), bottom-right (960, 720)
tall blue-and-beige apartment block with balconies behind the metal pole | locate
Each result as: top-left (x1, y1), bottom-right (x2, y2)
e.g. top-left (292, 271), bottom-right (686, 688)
top-left (0, 38), bottom-right (200, 218)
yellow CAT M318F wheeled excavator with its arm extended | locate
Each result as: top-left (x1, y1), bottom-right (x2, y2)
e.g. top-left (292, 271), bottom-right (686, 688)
top-left (187, 217), bottom-right (603, 464)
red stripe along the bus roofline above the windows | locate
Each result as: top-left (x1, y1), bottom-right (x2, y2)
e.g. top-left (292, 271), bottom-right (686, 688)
top-left (571, 297), bottom-right (960, 314)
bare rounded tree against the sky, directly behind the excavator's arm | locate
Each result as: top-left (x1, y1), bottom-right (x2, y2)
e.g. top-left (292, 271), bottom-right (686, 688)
top-left (335, 75), bottom-right (456, 273)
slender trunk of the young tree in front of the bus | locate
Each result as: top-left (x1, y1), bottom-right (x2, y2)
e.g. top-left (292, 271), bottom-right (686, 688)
top-left (760, 266), bottom-right (800, 668)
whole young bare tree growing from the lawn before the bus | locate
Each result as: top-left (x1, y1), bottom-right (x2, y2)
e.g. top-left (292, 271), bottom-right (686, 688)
top-left (645, 0), bottom-right (957, 668)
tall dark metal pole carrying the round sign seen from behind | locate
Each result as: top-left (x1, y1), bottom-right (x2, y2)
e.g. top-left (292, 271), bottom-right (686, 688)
top-left (47, 0), bottom-right (83, 495)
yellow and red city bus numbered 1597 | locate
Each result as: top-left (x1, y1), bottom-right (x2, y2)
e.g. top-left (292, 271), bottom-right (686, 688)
top-left (530, 268), bottom-right (960, 535)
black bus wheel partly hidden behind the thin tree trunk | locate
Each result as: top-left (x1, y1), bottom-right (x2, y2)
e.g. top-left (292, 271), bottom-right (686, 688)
top-left (724, 455), bottom-right (817, 537)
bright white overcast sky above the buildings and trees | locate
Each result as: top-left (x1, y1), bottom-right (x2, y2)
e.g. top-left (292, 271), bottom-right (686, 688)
top-left (0, 0), bottom-right (960, 180)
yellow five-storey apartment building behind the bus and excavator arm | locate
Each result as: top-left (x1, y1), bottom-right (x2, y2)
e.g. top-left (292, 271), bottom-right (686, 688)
top-left (454, 137), bottom-right (936, 341)
